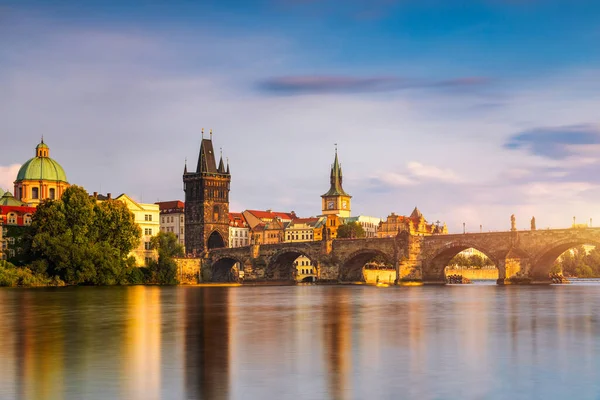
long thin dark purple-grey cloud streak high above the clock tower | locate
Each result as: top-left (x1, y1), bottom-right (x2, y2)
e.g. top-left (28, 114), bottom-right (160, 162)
top-left (258, 75), bottom-right (489, 95)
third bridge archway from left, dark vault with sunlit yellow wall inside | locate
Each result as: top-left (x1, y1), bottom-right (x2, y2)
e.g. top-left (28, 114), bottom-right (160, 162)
top-left (340, 250), bottom-right (396, 284)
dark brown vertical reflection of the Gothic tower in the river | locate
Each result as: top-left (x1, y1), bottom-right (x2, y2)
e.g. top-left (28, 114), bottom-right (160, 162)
top-left (184, 288), bottom-right (232, 400)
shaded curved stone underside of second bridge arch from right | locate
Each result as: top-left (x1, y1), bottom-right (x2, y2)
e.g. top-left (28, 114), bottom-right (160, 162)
top-left (422, 240), bottom-right (508, 283)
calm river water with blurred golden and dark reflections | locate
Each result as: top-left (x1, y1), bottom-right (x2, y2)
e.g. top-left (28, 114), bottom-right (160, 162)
top-left (0, 284), bottom-right (600, 400)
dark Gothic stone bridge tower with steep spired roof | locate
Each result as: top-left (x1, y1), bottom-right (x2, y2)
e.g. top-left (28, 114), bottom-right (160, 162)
top-left (183, 130), bottom-right (231, 255)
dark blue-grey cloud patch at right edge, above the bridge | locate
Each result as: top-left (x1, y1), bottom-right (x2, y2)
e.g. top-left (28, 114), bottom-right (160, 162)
top-left (504, 125), bottom-right (600, 159)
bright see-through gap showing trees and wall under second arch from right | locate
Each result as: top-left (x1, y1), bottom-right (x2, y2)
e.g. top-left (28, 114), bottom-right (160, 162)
top-left (444, 247), bottom-right (500, 285)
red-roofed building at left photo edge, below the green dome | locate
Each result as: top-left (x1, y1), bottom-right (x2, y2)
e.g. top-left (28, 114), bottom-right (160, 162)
top-left (0, 190), bottom-right (35, 260)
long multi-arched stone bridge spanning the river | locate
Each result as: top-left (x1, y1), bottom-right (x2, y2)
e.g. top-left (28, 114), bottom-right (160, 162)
top-left (202, 228), bottom-right (600, 284)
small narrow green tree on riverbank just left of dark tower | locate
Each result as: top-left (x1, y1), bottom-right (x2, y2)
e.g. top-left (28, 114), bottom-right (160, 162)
top-left (149, 232), bottom-right (183, 285)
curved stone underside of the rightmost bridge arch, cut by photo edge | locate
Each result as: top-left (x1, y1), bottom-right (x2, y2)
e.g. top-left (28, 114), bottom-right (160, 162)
top-left (529, 235), bottom-right (600, 280)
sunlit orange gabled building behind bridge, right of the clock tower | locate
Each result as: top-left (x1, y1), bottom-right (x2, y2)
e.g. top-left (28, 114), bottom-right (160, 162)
top-left (377, 207), bottom-right (448, 238)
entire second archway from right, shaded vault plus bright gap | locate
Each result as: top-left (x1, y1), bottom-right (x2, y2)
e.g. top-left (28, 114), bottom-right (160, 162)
top-left (423, 244), bottom-right (505, 284)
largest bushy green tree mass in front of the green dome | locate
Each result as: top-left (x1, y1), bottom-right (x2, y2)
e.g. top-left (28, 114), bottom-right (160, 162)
top-left (24, 186), bottom-right (141, 285)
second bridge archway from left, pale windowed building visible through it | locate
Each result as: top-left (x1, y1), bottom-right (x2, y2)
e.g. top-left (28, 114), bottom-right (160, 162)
top-left (265, 250), bottom-right (319, 283)
